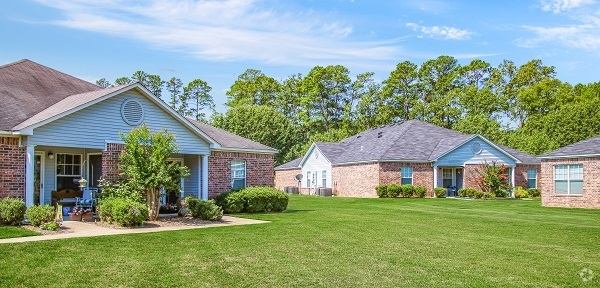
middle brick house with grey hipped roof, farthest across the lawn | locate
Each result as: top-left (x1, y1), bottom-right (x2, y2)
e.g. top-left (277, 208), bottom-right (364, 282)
top-left (275, 120), bottom-right (540, 197)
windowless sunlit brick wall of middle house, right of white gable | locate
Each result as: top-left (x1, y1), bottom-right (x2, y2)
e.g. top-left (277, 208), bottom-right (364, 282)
top-left (331, 162), bottom-right (379, 197)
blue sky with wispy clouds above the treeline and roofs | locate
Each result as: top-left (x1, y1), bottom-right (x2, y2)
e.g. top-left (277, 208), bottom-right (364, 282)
top-left (0, 0), bottom-right (600, 111)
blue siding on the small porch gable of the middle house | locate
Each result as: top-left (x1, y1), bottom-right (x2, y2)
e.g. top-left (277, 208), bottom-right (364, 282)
top-left (436, 138), bottom-right (515, 166)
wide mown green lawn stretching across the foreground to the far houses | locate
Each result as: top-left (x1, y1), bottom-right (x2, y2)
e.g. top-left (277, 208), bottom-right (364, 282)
top-left (0, 196), bottom-right (600, 287)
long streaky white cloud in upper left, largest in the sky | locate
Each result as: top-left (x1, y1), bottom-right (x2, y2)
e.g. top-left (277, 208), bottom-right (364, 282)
top-left (31, 0), bottom-right (400, 65)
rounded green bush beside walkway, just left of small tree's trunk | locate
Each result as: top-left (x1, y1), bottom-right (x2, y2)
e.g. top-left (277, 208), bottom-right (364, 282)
top-left (98, 197), bottom-right (148, 226)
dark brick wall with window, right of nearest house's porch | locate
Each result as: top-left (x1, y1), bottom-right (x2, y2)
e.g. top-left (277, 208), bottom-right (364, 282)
top-left (208, 151), bottom-right (275, 198)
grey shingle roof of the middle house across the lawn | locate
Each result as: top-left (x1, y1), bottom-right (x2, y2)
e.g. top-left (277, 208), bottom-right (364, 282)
top-left (278, 120), bottom-right (539, 167)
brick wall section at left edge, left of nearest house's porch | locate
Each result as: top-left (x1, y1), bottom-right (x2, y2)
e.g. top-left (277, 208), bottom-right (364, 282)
top-left (0, 137), bottom-right (25, 199)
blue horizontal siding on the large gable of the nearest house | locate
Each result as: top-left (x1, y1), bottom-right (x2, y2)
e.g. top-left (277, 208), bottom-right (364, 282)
top-left (29, 90), bottom-right (210, 154)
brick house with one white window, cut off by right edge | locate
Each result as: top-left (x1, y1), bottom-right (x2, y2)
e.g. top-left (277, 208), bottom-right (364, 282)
top-left (539, 136), bottom-right (600, 208)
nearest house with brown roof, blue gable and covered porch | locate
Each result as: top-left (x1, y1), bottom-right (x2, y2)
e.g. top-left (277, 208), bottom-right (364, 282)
top-left (0, 60), bottom-right (277, 206)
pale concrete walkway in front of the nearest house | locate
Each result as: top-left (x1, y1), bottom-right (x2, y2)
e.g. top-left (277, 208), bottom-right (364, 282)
top-left (0, 216), bottom-right (268, 244)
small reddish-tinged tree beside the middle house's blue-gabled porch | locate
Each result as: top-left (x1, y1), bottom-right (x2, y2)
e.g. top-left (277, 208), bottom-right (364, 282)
top-left (475, 161), bottom-right (510, 197)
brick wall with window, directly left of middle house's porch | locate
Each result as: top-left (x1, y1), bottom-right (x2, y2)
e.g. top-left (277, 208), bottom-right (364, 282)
top-left (379, 163), bottom-right (433, 197)
